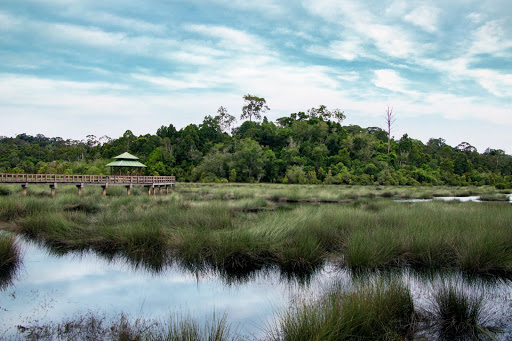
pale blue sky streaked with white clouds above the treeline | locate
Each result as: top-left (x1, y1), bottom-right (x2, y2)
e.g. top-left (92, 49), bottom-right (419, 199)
top-left (0, 0), bottom-right (512, 154)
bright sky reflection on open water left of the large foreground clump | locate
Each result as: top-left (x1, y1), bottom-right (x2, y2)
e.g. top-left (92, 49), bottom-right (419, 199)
top-left (0, 242), bottom-right (342, 335)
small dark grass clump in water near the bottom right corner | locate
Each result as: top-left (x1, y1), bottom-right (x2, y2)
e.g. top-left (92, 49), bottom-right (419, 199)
top-left (430, 281), bottom-right (499, 340)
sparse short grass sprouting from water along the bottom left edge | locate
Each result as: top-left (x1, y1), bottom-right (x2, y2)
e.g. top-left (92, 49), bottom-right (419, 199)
top-left (18, 312), bottom-right (237, 341)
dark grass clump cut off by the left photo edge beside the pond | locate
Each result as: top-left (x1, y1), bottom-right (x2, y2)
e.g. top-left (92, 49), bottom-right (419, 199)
top-left (0, 231), bottom-right (21, 288)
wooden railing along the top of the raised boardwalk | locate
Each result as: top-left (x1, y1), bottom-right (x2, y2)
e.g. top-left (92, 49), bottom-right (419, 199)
top-left (0, 173), bottom-right (176, 185)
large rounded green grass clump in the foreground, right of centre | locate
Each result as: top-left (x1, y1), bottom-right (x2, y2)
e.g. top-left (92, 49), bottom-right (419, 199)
top-left (269, 280), bottom-right (415, 341)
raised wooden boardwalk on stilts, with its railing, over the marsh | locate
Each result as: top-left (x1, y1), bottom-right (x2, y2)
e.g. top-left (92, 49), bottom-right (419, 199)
top-left (0, 173), bottom-right (176, 196)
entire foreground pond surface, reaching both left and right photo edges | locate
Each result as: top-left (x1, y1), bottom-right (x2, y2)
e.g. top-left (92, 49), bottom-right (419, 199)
top-left (0, 236), bottom-right (512, 339)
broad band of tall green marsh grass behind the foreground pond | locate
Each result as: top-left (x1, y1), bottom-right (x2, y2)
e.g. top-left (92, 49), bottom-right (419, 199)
top-left (0, 185), bottom-right (512, 275)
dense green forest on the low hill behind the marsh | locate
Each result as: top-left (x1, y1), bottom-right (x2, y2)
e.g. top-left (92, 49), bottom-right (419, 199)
top-left (0, 103), bottom-right (512, 189)
